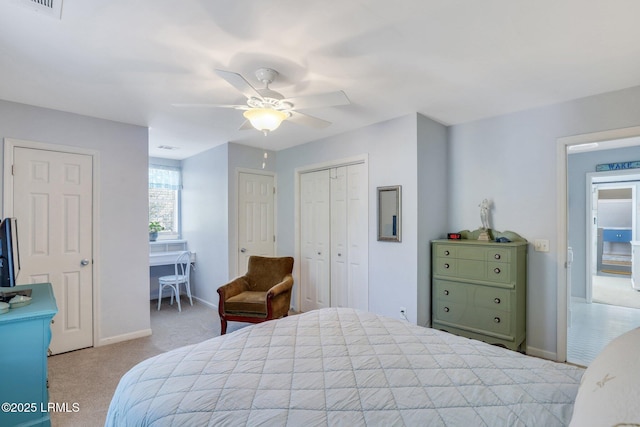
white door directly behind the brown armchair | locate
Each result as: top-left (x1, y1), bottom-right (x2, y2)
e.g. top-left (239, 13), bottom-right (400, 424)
top-left (237, 172), bottom-right (275, 276)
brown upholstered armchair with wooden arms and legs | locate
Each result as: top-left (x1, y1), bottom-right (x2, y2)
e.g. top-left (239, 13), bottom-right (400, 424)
top-left (218, 256), bottom-right (293, 335)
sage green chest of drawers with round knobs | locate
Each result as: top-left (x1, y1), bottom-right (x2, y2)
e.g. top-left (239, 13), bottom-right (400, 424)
top-left (431, 240), bottom-right (527, 352)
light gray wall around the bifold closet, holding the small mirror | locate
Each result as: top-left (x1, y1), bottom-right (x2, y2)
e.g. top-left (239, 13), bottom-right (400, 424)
top-left (277, 114), bottom-right (446, 323)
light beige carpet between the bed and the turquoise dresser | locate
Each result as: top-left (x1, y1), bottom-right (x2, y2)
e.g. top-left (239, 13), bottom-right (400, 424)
top-left (48, 297), bottom-right (248, 427)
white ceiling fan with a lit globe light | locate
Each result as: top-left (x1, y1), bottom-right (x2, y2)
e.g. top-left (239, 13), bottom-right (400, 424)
top-left (174, 68), bottom-right (350, 135)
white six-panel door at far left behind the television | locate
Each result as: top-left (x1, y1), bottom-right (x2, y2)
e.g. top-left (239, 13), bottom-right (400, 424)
top-left (13, 147), bottom-right (93, 354)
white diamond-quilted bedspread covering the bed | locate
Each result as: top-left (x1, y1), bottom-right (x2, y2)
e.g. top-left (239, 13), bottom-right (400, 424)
top-left (106, 308), bottom-right (584, 427)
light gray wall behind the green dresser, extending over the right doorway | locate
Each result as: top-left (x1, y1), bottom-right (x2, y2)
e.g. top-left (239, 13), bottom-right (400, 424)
top-left (449, 87), bottom-right (640, 357)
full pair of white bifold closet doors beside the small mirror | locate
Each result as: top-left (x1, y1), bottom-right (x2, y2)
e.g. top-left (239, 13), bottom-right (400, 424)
top-left (300, 163), bottom-right (369, 311)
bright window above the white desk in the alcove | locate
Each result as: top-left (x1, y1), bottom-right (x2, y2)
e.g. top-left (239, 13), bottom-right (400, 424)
top-left (149, 165), bottom-right (182, 239)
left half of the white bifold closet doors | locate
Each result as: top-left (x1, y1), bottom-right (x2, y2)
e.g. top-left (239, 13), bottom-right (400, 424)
top-left (300, 170), bottom-right (331, 311)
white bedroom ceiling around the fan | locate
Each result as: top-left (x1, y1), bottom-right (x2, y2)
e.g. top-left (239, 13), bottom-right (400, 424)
top-left (0, 0), bottom-right (640, 159)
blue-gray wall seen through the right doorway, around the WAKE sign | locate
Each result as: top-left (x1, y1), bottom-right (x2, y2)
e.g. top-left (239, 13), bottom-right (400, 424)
top-left (567, 145), bottom-right (640, 298)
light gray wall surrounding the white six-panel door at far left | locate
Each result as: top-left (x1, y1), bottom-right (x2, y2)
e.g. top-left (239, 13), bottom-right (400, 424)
top-left (0, 101), bottom-right (150, 344)
